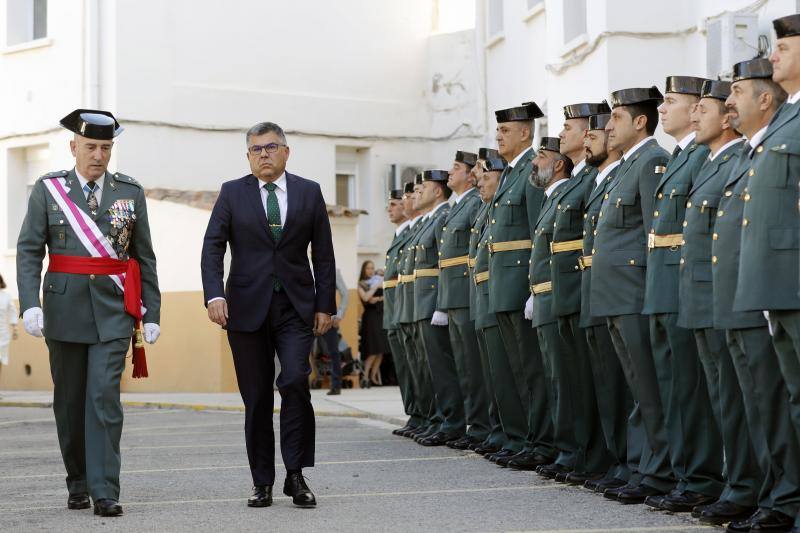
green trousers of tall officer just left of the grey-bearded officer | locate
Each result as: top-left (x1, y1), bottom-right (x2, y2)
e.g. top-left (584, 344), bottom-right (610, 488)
top-left (495, 311), bottom-right (558, 460)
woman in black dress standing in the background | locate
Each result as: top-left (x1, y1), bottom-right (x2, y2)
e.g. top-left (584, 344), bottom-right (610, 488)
top-left (358, 261), bottom-right (389, 386)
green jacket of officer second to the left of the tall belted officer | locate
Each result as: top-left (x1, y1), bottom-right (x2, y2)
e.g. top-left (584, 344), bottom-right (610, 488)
top-left (437, 188), bottom-right (482, 310)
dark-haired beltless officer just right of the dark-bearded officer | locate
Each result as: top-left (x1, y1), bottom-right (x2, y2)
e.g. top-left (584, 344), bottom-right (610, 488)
top-left (590, 87), bottom-right (675, 503)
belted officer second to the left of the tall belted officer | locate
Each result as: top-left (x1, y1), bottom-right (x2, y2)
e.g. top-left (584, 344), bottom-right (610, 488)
top-left (437, 150), bottom-right (490, 450)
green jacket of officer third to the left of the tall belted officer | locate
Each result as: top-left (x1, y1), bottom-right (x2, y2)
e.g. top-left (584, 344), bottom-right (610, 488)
top-left (414, 203), bottom-right (450, 322)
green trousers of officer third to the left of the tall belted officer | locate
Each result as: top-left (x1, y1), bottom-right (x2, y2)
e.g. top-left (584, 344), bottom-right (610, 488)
top-left (416, 318), bottom-right (466, 437)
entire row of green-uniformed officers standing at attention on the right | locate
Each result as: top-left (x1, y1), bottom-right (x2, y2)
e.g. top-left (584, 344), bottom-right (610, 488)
top-left (384, 15), bottom-right (800, 531)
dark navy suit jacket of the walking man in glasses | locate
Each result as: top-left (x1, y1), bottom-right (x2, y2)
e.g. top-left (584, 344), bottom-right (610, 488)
top-left (200, 172), bottom-right (336, 331)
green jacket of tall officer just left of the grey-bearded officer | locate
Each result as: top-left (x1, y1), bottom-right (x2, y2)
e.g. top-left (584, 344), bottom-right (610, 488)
top-left (488, 148), bottom-right (544, 313)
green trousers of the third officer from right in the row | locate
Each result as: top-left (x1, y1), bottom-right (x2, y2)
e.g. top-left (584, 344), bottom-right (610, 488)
top-left (694, 328), bottom-right (763, 507)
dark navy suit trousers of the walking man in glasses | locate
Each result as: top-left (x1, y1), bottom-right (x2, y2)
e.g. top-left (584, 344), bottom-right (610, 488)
top-left (228, 291), bottom-right (315, 485)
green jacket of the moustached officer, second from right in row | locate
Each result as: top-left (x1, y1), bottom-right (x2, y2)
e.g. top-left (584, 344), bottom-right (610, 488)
top-left (711, 142), bottom-right (767, 329)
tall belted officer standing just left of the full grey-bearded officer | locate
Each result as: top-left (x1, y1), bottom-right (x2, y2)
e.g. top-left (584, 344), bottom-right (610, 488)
top-left (488, 102), bottom-right (557, 468)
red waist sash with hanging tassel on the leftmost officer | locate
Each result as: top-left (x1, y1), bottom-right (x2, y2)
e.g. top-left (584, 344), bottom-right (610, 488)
top-left (47, 254), bottom-right (148, 378)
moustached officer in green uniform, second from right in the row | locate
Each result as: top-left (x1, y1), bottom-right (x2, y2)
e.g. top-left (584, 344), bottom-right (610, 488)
top-left (716, 59), bottom-right (800, 531)
